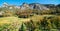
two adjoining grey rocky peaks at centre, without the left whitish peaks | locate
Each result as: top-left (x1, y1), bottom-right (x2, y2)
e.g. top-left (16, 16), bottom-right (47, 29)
top-left (20, 3), bottom-right (49, 10)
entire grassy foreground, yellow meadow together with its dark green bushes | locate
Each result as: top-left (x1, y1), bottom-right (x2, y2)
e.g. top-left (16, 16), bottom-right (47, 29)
top-left (0, 15), bottom-right (60, 31)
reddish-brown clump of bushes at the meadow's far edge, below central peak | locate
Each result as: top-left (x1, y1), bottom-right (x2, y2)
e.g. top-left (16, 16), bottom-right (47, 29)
top-left (16, 10), bottom-right (33, 18)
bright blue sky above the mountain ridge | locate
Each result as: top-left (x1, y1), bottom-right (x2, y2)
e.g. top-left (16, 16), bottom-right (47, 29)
top-left (0, 0), bottom-right (60, 6)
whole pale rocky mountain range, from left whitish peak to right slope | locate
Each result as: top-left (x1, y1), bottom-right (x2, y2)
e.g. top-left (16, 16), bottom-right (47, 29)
top-left (2, 2), bottom-right (49, 10)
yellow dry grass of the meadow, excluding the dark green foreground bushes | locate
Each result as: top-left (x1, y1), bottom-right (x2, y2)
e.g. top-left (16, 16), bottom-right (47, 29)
top-left (0, 15), bottom-right (60, 31)
